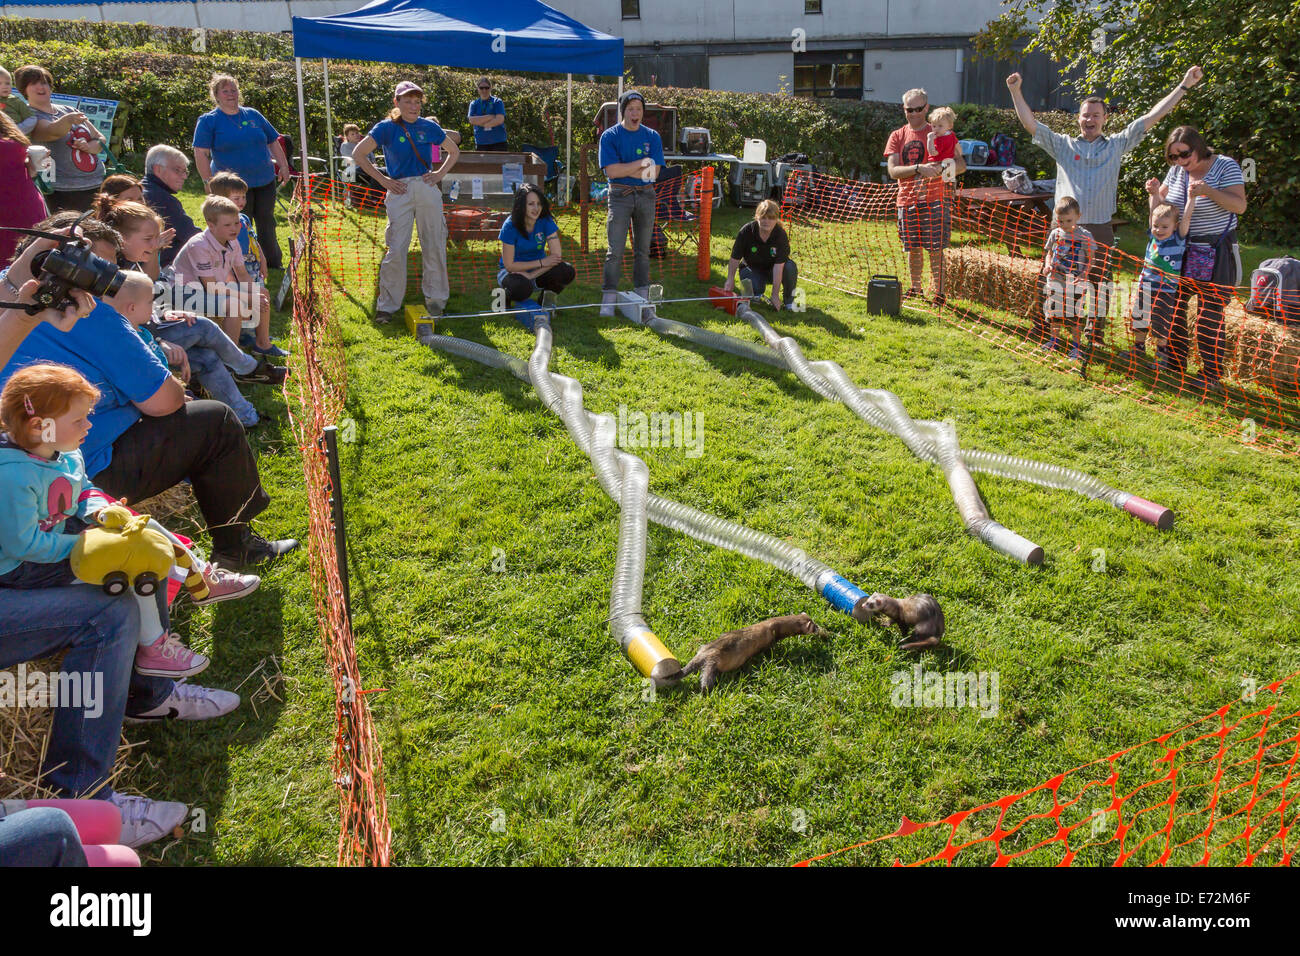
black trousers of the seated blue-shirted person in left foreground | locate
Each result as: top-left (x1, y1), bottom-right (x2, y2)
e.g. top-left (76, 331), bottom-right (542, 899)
top-left (94, 402), bottom-right (270, 551)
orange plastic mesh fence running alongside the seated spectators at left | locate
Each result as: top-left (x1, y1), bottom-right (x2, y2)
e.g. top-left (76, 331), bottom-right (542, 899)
top-left (285, 189), bottom-right (391, 866)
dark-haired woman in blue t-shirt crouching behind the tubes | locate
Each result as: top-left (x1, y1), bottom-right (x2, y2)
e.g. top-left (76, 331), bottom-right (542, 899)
top-left (497, 182), bottom-right (577, 308)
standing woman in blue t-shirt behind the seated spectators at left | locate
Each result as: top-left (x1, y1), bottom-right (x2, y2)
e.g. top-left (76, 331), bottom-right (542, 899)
top-left (194, 73), bottom-right (289, 269)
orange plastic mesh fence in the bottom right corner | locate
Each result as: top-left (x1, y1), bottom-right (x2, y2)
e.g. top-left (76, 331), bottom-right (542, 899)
top-left (796, 671), bottom-right (1300, 866)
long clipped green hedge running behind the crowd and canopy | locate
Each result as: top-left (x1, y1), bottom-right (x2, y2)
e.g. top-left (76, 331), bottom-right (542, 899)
top-left (0, 20), bottom-right (1279, 241)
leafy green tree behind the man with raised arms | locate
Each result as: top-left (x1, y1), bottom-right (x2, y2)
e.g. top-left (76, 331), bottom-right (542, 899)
top-left (975, 0), bottom-right (1300, 245)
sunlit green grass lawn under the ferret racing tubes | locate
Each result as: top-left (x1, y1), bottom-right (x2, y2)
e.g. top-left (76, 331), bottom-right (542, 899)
top-left (133, 194), bottom-right (1300, 865)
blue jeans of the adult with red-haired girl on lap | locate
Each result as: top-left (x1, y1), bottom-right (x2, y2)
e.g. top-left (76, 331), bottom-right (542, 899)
top-left (0, 584), bottom-right (173, 800)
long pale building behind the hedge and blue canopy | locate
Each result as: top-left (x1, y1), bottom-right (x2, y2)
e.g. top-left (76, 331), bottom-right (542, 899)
top-left (0, 0), bottom-right (1075, 109)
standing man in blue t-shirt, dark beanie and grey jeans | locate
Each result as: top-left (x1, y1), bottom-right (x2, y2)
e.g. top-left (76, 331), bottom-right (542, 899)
top-left (599, 90), bottom-right (663, 319)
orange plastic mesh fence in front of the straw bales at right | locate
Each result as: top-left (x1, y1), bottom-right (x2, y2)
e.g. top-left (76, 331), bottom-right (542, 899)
top-left (783, 170), bottom-right (1300, 455)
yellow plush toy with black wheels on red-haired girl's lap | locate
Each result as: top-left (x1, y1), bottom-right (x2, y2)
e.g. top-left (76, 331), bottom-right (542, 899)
top-left (70, 505), bottom-right (208, 598)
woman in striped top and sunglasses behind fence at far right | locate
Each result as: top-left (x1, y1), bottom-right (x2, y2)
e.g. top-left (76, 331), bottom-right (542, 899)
top-left (1161, 126), bottom-right (1245, 392)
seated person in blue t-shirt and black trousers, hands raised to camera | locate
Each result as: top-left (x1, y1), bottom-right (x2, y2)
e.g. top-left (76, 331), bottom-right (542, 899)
top-left (0, 221), bottom-right (298, 568)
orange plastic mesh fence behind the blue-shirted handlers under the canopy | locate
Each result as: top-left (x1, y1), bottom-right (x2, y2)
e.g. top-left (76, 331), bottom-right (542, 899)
top-left (312, 166), bottom-right (714, 312)
